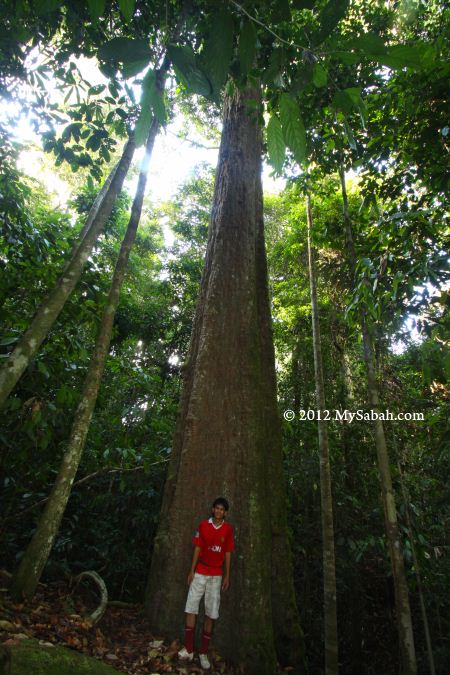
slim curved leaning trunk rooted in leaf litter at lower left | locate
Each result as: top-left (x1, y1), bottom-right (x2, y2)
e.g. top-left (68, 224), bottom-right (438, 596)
top-left (11, 120), bottom-right (159, 598)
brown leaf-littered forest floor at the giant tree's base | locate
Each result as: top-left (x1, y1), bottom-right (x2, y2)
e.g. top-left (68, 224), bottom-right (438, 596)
top-left (0, 582), bottom-right (240, 675)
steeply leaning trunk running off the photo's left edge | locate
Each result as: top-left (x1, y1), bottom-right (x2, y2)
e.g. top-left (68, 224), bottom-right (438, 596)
top-left (0, 139), bottom-right (135, 406)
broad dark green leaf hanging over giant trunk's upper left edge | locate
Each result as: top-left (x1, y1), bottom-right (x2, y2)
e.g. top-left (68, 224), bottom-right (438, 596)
top-left (202, 8), bottom-right (234, 96)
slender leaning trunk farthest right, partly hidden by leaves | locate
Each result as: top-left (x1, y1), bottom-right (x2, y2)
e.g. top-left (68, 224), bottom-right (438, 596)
top-left (339, 165), bottom-right (417, 675)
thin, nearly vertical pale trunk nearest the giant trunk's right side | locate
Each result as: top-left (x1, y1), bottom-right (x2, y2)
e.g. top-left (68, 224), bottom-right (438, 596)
top-left (306, 194), bottom-right (339, 675)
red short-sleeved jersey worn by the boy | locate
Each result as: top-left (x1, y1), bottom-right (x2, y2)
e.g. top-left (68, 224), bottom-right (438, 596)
top-left (193, 518), bottom-right (234, 576)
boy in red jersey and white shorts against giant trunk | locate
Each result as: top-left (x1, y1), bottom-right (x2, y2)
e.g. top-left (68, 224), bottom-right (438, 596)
top-left (178, 497), bottom-right (234, 670)
